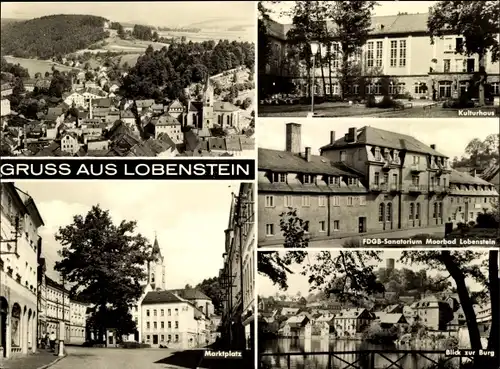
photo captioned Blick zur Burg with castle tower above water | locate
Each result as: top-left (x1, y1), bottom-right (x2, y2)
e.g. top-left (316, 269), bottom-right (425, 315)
top-left (257, 248), bottom-right (500, 369)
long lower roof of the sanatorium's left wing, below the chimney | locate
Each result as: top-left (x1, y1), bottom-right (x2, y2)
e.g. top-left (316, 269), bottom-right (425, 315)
top-left (258, 148), bottom-right (358, 177)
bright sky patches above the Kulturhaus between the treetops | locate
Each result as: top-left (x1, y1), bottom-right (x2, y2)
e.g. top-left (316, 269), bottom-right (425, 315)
top-left (266, 1), bottom-right (437, 24)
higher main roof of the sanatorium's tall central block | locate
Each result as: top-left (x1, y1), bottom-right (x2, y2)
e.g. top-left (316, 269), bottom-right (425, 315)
top-left (320, 126), bottom-right (446, 157)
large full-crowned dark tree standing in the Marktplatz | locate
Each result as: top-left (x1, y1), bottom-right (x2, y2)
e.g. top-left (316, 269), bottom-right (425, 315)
top-left (55, 205), bottom-right (152, 344)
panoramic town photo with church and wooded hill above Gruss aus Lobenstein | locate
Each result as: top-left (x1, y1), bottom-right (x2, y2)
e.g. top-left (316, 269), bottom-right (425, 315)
top-left (0, 1), bottom-right (257, 158)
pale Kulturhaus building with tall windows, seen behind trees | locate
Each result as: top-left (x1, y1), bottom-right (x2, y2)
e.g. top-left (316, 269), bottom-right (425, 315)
top-left (259, 13), bottom-right (500, 99)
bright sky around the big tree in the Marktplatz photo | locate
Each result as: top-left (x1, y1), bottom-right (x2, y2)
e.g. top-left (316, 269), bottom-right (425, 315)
top-left (16, 181), bottom-right (239, 289)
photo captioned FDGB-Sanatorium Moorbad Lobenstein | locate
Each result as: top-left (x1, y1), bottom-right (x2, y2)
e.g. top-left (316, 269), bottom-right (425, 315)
top-left (257, 118), bottom-right (500, 247)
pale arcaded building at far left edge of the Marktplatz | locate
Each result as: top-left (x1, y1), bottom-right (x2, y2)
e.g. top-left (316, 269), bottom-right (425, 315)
top-left (0, 183), bottom-right (44, 357)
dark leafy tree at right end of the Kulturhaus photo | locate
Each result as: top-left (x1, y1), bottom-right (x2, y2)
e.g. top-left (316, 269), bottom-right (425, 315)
top-left (427, 1), bottom-right (500, 106)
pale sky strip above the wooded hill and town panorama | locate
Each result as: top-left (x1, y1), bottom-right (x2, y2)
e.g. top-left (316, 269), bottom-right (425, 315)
top-left (1, 1), bottom-right (256, 27)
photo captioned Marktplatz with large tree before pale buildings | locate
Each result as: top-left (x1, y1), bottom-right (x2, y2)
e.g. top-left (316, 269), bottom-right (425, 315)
top-left (0, 181), bottom-right (256, 369)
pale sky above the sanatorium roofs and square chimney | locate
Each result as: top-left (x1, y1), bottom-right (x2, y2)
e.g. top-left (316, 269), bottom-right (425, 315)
top-left (258, 118), bottom-right (499, 159)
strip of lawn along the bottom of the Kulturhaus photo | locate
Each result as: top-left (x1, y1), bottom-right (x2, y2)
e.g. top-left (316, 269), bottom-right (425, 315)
top-left (258, 102), bottom-right (496, 118)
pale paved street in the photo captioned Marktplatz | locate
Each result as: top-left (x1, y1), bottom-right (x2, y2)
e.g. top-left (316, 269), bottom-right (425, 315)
top-left (50, 347), bottom-right (252, 369)
